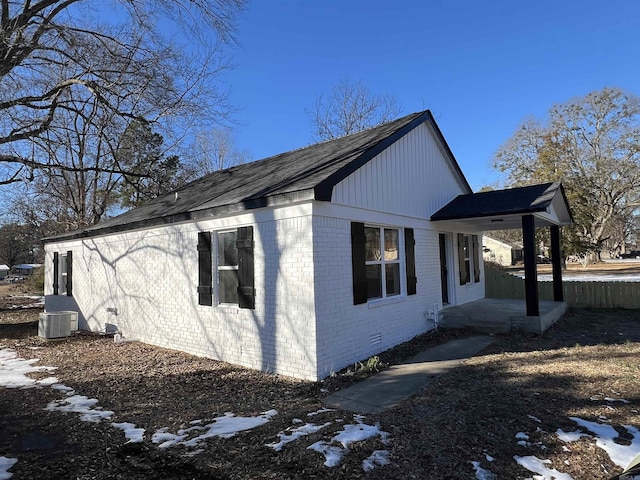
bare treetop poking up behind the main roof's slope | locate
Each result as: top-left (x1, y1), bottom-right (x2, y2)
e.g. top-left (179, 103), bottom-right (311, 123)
top-left (307, 77), bottom-right (400, 140)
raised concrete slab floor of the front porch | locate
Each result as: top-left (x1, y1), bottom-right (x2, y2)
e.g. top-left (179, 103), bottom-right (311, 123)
top-left (439, 298), bottom-right (567, 335)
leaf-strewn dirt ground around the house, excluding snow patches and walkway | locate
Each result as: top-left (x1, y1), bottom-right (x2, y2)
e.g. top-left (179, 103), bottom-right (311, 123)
top-left (0, 270), bottom-right (640, 480)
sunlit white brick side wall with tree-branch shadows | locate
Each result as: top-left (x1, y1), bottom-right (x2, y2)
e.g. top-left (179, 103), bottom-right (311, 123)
top-left (45, 205), bottom-right (317, 380)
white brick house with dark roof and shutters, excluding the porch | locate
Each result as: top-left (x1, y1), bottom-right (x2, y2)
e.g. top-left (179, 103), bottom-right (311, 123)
top-left (45, 111), bottom-right (484, 380)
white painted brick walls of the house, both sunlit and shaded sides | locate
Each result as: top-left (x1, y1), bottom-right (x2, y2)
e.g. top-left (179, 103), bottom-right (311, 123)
top-left (45, 201), bottom-right (484, 380)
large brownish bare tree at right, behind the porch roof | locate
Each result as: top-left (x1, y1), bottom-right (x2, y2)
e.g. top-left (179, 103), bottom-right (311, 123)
top-left (494, 88), bottom-right (640, 256)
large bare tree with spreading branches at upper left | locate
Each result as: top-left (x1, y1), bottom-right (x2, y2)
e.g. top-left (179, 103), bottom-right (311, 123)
top-left (0, 0), bottom-right (245, 185)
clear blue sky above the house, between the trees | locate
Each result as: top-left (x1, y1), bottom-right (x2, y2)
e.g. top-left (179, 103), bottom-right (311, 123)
top-left (225, 0), bottom-right (640, 190)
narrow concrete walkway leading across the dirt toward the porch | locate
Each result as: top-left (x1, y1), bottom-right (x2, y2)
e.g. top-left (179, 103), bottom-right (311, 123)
top-left (323, 335), bottom-right (493, 413)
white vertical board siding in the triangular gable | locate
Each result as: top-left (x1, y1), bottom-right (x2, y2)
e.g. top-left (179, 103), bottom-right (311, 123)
top-left (331, 124), bottom-right (469, 219)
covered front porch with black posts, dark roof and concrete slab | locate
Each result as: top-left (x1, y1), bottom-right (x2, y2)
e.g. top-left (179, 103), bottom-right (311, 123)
top-left (431, 182), bottom-right (572, 334)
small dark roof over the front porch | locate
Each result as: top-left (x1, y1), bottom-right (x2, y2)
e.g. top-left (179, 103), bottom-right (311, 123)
top-left (431, 182), bottom-right (566, 221)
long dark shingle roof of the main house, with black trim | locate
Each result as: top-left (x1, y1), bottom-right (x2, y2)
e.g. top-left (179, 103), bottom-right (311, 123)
top-left (44, 110), bottom-right (471, 242)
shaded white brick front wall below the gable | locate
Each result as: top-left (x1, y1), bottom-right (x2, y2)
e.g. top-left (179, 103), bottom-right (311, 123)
top-left (313, 213), bottom-right (441, 378)
